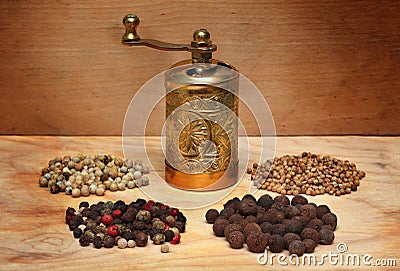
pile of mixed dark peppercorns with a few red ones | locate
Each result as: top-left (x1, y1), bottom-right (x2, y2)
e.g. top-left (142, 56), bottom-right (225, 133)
top-left (65, 199), bottom-right (186, 248)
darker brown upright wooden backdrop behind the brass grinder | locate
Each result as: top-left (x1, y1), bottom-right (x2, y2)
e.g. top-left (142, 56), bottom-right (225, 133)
top-left (0, 0), bottom-right (400, 135)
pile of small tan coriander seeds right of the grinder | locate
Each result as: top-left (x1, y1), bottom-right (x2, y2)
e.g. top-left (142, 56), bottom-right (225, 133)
top-left (247, 152), bottom-right (365, 196)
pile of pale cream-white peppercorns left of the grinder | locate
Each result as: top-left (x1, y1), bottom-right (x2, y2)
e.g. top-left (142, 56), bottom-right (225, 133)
top-left (39, 153), bottom-right (149, 197)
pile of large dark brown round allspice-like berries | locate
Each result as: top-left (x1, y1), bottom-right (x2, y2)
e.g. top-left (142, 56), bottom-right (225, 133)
top-left (206, 194), bottom-right (337, 256)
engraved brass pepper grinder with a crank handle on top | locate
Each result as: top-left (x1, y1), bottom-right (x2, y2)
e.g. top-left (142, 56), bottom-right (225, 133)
top-left (122, 14), bottom-right (239, 191)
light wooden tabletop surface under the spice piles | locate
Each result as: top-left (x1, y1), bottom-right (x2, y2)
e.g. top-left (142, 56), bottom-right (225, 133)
top-left (0, 136), bottom-right (400, 270)
